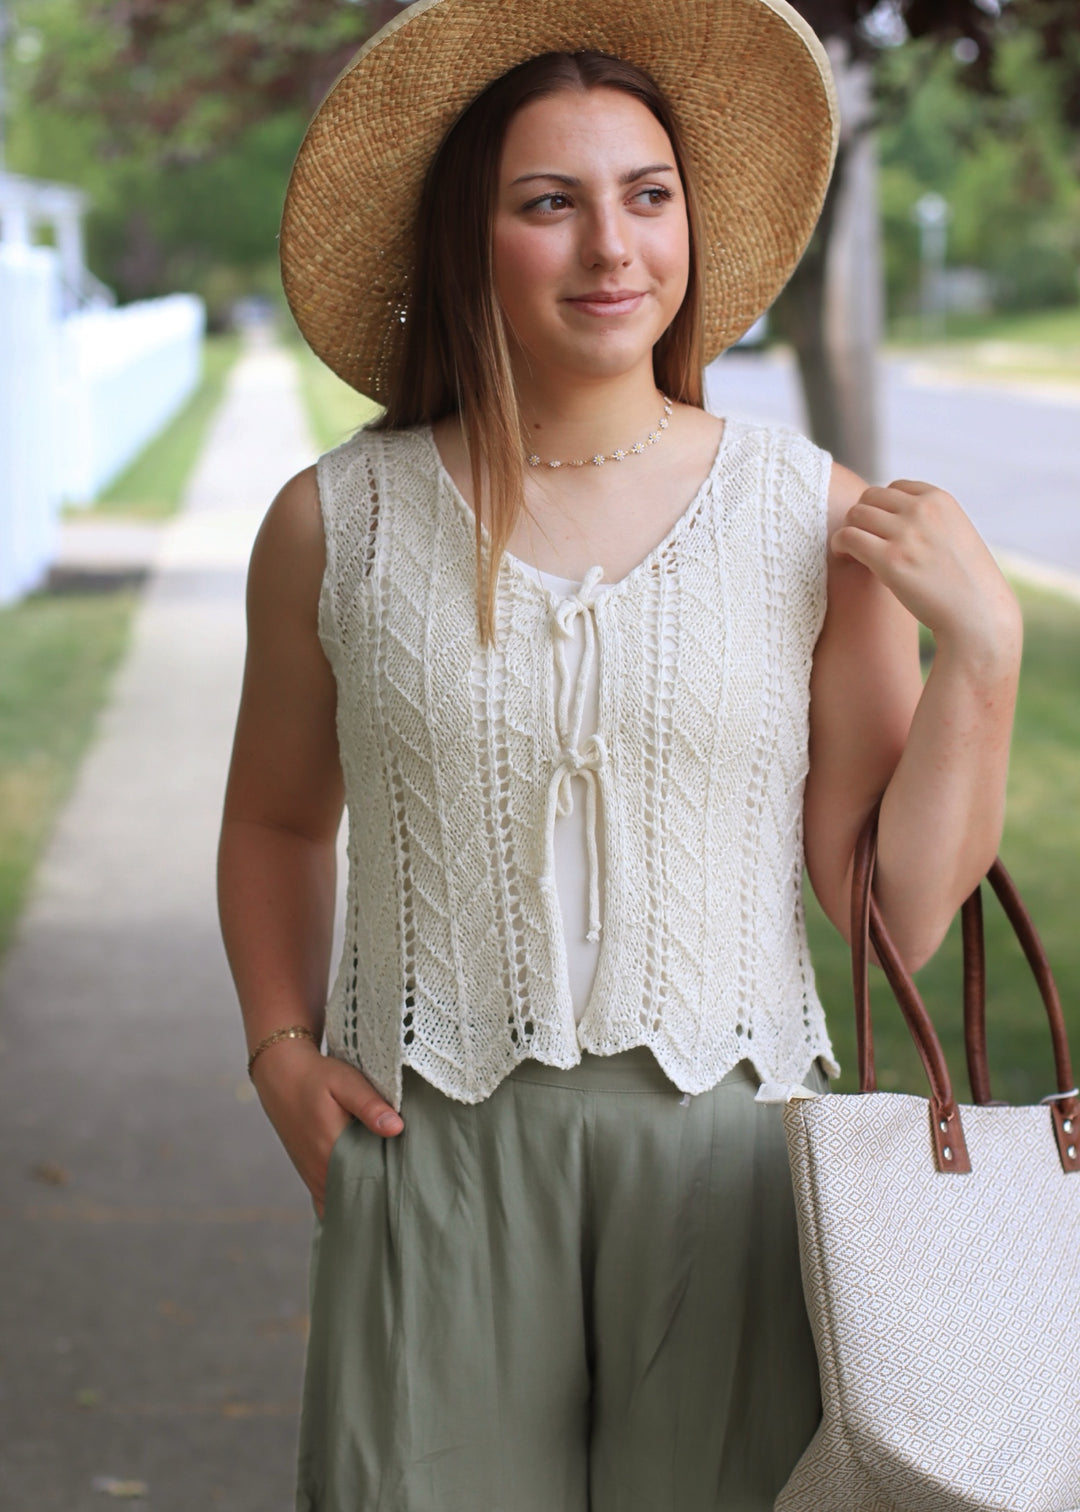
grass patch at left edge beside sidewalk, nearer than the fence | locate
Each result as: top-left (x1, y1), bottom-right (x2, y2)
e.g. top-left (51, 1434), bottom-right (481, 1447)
top-left (0, 590), bottom-right (136, 953)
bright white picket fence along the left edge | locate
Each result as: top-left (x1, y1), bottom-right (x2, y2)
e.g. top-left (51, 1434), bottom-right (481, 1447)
top-left (0, 242), bottom-right (204, 605)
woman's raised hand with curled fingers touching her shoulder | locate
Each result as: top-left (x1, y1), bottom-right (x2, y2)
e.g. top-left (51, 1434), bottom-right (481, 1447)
top-left (830, 478), bottom-right (1019, 658)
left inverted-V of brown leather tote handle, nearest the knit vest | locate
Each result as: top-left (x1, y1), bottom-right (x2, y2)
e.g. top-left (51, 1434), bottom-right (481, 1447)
top-left (852, 803), bottom-right (971, 1175)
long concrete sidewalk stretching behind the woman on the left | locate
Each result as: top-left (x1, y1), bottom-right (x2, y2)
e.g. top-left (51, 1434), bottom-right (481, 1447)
top-left (0, 334), bottom-right (315, 1512)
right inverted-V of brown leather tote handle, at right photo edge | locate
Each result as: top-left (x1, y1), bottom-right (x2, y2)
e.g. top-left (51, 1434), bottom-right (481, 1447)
top-left (962, 859), bottom-right (1080, 1170)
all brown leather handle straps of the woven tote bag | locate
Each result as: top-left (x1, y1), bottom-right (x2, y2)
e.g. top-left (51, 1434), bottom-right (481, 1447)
top-left (852, 803), bottom-right (1080, 1172)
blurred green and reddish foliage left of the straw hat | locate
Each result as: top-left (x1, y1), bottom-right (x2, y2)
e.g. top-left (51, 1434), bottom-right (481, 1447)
top-left (6, 0), bottom-right (369, 327)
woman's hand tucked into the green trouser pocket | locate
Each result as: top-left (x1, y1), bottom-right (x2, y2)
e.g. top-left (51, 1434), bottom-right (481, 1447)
top-left (251, 1040), bottom-right (405, 1219)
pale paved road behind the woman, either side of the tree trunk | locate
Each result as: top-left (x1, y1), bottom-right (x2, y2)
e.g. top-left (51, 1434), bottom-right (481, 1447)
top-left (708, 352), bottom-right (1080, 573)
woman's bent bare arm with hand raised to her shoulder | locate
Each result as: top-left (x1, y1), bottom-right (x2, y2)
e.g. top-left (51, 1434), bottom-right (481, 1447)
top-left (805, 467), bottom-right (1023, 969)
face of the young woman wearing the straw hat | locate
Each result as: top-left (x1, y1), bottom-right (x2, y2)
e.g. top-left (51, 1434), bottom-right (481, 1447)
top-left (493, 89), bottom-right (690, 376)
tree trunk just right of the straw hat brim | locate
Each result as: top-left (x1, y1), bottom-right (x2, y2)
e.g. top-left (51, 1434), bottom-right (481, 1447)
top-left (773, 38), bottom-right (883, 481)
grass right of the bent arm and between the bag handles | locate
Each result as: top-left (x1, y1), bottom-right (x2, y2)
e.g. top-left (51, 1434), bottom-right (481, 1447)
top-left (808, 588), bottom-right (1080, 1102)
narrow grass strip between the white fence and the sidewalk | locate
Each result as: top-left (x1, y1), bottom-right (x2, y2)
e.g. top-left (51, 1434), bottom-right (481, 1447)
top-left (85, 336), bottom-right (241, 520)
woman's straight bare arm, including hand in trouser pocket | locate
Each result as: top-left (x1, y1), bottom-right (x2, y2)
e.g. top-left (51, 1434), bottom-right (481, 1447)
top-left (218, 469), bottom-right (402, 1213)
